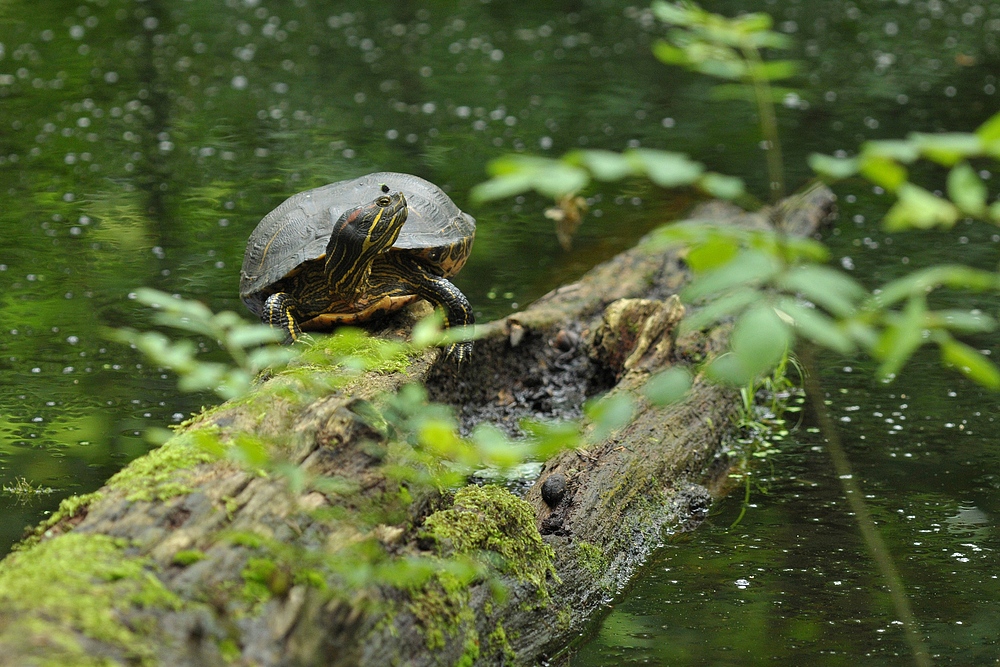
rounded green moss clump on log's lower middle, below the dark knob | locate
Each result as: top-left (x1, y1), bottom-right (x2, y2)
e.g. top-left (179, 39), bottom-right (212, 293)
top-left (424, 486), bottom-right (555, 592)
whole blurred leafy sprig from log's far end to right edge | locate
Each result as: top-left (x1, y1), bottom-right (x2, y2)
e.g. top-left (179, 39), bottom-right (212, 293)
top-left (657, 211), bottom-right (1000, 388)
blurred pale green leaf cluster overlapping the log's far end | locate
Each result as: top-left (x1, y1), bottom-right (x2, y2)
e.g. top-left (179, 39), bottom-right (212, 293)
top-left (656, 215), bottom-right (867, 387)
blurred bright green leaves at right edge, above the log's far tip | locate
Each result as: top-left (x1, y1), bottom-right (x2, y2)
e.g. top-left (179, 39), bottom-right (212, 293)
top-left (809, 113), bottom-right (1000, 231)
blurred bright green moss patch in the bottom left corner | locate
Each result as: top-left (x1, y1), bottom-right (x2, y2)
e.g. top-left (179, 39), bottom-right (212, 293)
top-left (0, 533), bottom-right (181, 664)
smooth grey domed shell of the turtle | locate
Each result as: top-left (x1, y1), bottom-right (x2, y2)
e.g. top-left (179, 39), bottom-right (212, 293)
top-left (240, 171), bottom-right (476, 312)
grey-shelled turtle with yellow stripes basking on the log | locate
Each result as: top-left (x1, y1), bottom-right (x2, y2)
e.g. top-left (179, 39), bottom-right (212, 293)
top-left (240, 172), bottom-right (476, 363)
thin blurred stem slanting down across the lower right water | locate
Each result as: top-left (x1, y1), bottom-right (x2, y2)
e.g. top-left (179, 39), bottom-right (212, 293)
top-left (799, 347), bottom-right (931, 667)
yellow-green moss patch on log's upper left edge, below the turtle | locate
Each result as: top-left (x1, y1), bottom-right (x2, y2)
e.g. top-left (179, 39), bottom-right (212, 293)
top-left (107, 431), bottom-right (216, 501)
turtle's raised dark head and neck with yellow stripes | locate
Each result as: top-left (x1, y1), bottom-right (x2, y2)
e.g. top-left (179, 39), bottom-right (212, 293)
top-left (325, 185), bottom-right (406, 297)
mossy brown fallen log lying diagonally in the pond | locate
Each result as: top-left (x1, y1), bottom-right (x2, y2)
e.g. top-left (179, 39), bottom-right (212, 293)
top-left (0, 188), bottom-right (832, 666)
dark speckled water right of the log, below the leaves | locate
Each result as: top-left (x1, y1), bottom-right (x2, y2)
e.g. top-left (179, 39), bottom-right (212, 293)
top-left (570, 348), bottom-right (1000, 667)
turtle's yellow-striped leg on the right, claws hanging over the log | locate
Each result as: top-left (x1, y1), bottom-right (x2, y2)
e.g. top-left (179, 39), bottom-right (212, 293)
top-left (380, 252), bottom-right (476, 364)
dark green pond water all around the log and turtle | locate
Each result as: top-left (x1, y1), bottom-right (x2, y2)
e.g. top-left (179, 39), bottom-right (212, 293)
top-left (0, 0), bottom-right (1000, 665)
